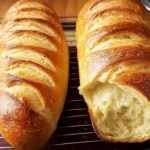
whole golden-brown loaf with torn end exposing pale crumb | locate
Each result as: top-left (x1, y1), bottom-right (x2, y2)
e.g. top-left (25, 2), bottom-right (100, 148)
top-left (76, 0), bottom-right (150, 142)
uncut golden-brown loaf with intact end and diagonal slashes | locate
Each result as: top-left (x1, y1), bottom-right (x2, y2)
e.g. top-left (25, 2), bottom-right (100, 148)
top-left (0, 0), bottom-right (69, 150)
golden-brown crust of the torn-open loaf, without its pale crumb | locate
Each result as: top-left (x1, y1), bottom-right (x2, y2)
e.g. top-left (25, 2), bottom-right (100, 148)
top-left (76, 0), bottom-right (150, 142)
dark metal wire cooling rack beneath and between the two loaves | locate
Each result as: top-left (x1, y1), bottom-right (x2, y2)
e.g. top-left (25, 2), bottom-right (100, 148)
top-left (0, 16), bottom-right (150, 150)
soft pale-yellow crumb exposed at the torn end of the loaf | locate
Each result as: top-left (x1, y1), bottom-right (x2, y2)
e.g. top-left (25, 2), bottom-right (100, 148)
top-left (84, 82), bottom-right (150, 142)
